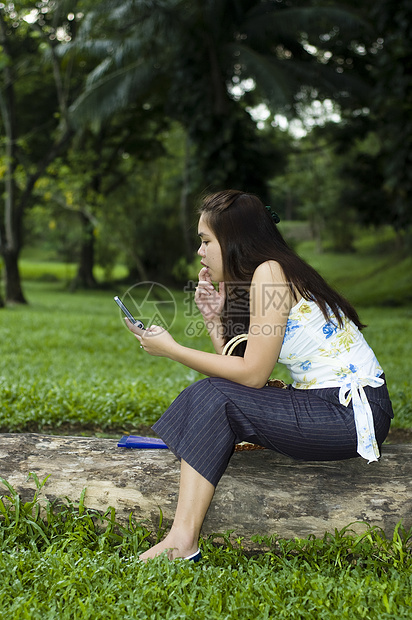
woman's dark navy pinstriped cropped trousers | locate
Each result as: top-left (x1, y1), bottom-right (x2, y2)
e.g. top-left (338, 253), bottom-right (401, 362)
top-left (153, 378), bottom-right (393, 486)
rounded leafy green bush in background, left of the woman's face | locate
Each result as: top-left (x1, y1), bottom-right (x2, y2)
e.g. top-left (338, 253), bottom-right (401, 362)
top-left (26, 120), bottom-right (194, 282)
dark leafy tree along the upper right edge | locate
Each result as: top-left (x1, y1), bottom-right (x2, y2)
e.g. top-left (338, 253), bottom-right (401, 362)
top-left (312, 0), bottom-right (412, 239)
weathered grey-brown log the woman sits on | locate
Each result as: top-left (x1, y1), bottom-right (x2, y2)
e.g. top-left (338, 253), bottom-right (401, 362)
top-left (0, 433), bottom-right (412, 542)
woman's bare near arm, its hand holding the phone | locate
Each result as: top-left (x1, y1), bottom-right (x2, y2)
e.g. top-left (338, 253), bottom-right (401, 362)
top-left (129, 261), bottom-right (292, 388)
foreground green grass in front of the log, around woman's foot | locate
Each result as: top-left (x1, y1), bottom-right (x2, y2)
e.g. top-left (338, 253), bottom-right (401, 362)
top-left (0, 474), bottom-right (412, 620)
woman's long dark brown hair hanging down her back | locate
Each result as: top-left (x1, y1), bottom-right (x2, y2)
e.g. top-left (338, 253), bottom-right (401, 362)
top-left (199, 189), bottom-right (365, 352)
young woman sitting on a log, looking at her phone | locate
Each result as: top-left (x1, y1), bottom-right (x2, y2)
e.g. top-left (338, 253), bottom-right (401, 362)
top-left (124, 190), bottom-right (393, 560)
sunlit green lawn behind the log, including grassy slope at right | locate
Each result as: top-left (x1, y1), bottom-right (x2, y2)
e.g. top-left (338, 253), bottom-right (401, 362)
top-left (0, 233), bottom-right (412, 434)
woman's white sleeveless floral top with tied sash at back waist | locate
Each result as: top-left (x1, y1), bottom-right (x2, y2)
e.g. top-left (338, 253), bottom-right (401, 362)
top-left (278, 299), bottom-right (384, 463)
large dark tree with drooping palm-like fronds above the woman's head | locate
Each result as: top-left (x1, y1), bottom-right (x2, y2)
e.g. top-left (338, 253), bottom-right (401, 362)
top-left (65, 0), bottom-right (370, 208)
